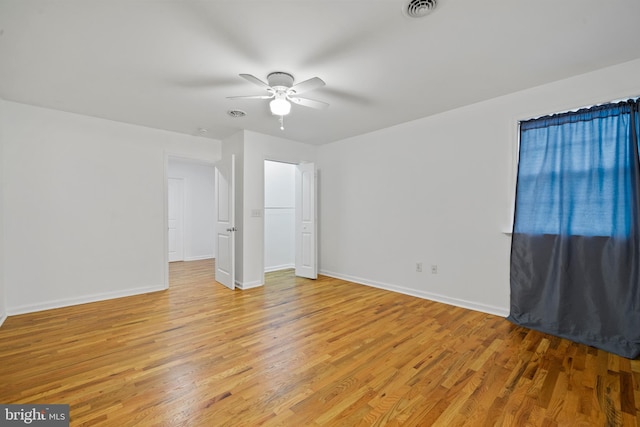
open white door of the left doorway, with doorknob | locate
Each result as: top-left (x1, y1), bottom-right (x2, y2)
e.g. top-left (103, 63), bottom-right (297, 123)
top-left (216, 155), bottom-right (236, 289)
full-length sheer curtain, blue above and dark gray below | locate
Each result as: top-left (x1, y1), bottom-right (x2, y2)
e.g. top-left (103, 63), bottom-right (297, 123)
top-left (508, 101), bottom-right (640, 358)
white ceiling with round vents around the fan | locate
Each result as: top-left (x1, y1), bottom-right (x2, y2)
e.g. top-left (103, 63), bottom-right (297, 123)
top-left (0, 0), bottom-right (640, 144)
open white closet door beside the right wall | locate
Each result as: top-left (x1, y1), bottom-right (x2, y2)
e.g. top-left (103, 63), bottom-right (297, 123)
top-left (296, 163), bottom-right (318, 279)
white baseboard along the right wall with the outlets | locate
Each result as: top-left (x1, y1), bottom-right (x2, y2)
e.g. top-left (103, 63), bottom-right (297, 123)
top-left (320, 270), bottom-right (509, 317)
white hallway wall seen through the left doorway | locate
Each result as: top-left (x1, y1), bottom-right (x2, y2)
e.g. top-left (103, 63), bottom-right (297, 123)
top-left (168, 157), bottom-right (216, 261)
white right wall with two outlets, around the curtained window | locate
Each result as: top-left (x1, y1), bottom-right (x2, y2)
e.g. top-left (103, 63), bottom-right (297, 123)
top-left (318, 60), bottom-right (640, 315)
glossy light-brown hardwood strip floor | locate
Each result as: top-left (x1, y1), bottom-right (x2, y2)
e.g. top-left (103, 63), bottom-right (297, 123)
top-left (0, 260), bottom-right (640, 426)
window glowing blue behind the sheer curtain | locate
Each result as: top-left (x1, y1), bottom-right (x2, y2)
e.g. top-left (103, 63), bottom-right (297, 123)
top-left (514, 103), bottom-right (637, 236)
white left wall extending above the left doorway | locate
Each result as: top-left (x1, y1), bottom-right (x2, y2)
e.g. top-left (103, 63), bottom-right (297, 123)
top-left (2, 102), bottom-right (221, 314)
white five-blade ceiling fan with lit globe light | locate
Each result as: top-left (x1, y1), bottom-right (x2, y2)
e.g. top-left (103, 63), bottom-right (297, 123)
top-left (228, 71), bottom-right (329, 129)
